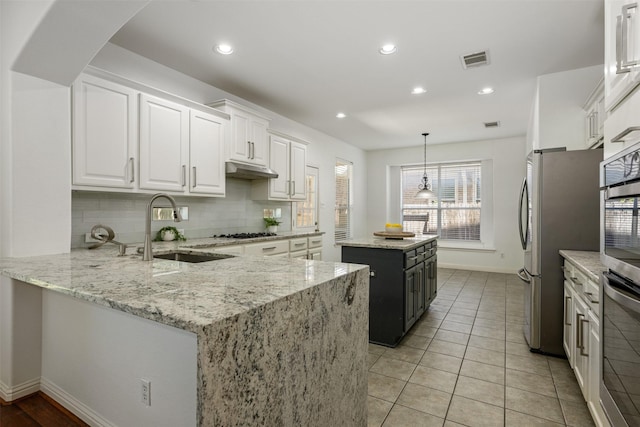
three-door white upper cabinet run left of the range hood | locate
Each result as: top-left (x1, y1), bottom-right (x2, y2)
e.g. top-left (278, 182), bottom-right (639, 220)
top-left (72, 68), bottom-right (230, 197)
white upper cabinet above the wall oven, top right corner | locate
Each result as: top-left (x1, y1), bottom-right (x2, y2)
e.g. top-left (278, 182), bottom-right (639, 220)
top-left (604, 0), bottom-right (640, 111)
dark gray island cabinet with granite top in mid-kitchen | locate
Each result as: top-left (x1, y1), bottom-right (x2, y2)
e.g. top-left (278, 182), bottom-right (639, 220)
top-left (340, 236), bottom-right (438, 347)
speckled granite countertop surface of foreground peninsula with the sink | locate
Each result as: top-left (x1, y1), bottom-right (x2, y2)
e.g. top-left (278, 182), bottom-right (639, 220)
top-left (0, 239), bottom-right (363, 332)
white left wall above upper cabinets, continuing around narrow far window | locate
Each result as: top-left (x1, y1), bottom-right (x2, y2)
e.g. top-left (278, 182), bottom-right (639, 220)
top-left (91, 44), bottom-right (367, 261)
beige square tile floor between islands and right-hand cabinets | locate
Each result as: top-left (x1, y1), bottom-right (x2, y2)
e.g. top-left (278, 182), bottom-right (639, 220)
top-left (368, 269), bottom-right (593, 427)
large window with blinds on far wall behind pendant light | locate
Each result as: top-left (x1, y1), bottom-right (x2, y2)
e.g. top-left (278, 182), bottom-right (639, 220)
top-left (401, 162), bottom-right (482, 241)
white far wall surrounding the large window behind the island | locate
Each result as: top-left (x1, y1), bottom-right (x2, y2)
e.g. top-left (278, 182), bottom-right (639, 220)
top-left (365, 137), bottom-right (526, 273)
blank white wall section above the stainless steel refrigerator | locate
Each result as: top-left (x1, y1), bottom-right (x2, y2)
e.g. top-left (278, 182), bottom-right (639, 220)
top-left (525, 65), bottom-right (604, 153)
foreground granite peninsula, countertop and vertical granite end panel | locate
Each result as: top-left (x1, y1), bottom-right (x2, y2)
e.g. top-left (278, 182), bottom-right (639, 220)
top-left (0, 244), bottom-right (369, 426)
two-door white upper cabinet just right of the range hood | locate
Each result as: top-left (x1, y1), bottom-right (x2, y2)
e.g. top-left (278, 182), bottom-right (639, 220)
top-left (251, 131), bottom-right (307, 200)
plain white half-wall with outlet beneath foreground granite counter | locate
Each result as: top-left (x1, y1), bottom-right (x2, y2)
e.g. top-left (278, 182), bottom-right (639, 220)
top-left (42, 291), bottom-right (197, 427)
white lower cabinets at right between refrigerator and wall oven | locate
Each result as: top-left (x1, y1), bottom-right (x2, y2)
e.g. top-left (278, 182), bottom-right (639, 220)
top-left (563, 259), bottom-right (609, 427)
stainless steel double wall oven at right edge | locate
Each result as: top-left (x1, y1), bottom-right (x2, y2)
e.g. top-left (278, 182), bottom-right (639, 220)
top-left (600, 144), bottom-right (640, 427)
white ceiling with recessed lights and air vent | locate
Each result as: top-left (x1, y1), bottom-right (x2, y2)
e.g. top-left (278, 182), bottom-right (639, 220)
top-left (111, 0), bottom-right (604, 150)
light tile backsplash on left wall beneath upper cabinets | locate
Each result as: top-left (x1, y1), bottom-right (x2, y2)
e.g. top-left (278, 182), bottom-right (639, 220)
top-left (71, 178), bottom-right (291, 248)
